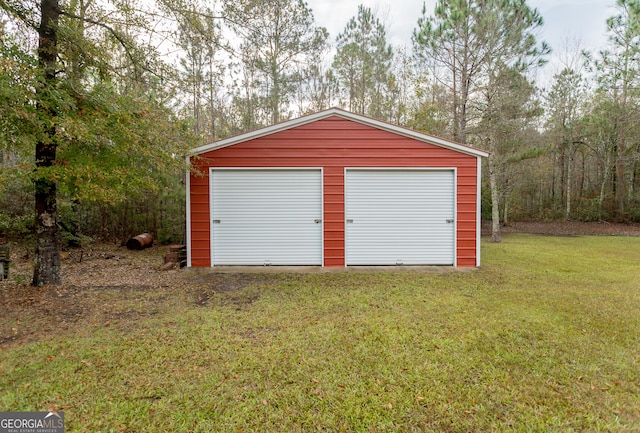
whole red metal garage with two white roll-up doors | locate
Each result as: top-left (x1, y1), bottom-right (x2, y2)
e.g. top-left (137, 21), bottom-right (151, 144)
top-left (187, 108), bottom-right (487, 267)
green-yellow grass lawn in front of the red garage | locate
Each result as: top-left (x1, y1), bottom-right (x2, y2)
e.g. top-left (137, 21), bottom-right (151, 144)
top-left (0, 235), bottom-right (640, 433)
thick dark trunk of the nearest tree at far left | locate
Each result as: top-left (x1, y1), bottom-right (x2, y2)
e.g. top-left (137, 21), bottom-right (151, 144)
top-left (32, 0), bottom-right (61, 286)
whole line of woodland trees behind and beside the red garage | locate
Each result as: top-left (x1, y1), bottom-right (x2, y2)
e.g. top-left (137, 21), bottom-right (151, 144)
top-left (0, 0), bottom-right (640, 285)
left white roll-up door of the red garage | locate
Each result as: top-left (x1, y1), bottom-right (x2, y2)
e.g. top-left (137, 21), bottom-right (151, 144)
top-left (211, 169), bottom-right (322, 266)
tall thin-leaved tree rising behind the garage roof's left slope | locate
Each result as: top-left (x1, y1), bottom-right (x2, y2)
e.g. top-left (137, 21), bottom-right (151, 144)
top-left (224, 0), bottom-right (328, 123)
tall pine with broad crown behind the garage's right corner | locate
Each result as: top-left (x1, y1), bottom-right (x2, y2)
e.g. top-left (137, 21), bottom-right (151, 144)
top-left (413, 0), bottom-right (550, 242)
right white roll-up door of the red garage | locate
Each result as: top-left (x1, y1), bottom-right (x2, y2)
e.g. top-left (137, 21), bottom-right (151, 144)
top-left (345, 169), bottom-right (455, 265)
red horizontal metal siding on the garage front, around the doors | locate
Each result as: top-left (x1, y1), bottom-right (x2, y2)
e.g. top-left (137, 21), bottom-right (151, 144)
top-left (190, 117), bottom-right (477, 266)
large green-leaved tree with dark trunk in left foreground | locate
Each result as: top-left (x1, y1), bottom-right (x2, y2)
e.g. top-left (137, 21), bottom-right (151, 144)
top-left (0, 0), bottom-right (194, 286)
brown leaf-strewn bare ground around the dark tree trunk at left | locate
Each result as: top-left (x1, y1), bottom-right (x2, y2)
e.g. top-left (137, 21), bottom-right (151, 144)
top-left (0, 245), bottom-right (275, 347)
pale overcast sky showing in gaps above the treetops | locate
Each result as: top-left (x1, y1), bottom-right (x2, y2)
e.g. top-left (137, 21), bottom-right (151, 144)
top-left (307, 0), bottom-right (616, 83)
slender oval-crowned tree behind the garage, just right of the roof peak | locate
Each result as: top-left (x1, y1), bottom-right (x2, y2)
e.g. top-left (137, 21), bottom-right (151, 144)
top-left (333, 5), bottom-right (395, 120)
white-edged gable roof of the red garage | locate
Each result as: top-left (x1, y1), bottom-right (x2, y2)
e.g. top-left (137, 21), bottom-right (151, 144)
top-left (189, 108), bottom-right (489, 157)
